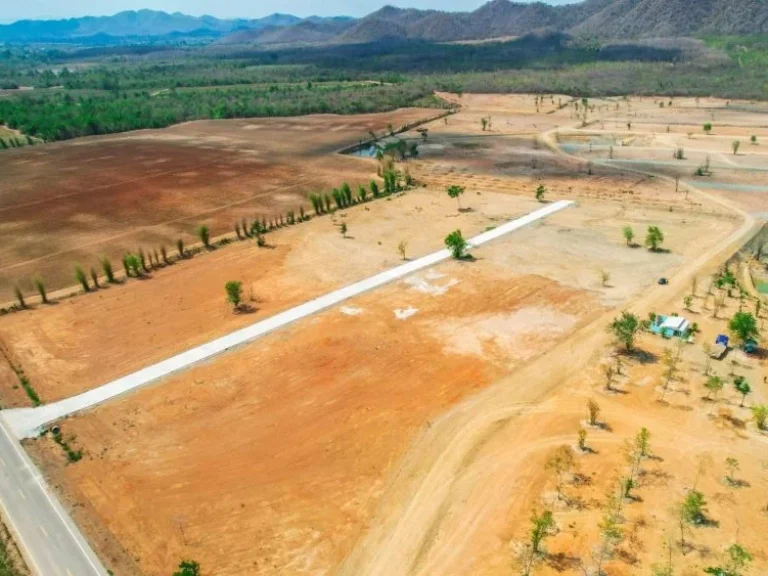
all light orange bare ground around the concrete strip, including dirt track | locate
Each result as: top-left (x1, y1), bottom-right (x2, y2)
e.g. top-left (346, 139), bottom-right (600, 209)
top-left (6, 95), bottom-right (768, 576)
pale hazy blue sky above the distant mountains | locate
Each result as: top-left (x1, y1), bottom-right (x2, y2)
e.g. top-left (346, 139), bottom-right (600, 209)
top-left (0, 0), bottom-right (567, 22)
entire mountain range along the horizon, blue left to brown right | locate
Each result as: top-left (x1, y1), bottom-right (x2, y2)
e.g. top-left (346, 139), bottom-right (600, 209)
top-left (0, 0), bottom-right (768, 46)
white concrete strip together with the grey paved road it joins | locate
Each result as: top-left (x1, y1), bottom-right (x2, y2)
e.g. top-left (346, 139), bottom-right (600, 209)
top-left (0, 201), bottom-right (573, 576)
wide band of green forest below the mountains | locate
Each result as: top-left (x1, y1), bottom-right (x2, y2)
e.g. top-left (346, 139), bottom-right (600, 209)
top-left (0, 34), bottom-right (768, 143)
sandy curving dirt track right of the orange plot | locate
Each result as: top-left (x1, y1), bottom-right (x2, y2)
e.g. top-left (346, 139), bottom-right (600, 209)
top-left (336, 119), bottom-right (758, 576)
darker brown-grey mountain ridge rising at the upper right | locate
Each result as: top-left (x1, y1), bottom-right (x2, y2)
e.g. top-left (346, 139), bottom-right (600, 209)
top-left (324, 0), bottom-right (768, 42)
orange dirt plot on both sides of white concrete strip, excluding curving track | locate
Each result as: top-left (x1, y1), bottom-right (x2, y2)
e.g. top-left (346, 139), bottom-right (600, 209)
top-left (21, 190), bottom-right (732, 575)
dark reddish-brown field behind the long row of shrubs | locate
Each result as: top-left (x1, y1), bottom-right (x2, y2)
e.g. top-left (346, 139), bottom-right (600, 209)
top-left (0, 109), bottom-right (435, 303)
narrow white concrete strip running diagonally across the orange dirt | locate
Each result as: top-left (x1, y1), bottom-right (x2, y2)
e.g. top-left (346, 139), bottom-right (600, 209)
top-left (2, 200), bottom-right (574, 438)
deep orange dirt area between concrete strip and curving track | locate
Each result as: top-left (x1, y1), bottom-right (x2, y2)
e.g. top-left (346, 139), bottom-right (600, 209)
top-left (30, 263), bottom-right (600, 575)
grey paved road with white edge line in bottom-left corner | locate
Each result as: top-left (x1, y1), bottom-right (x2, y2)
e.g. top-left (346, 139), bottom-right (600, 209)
top-left (0, 417), bottom-right (107, 576)
